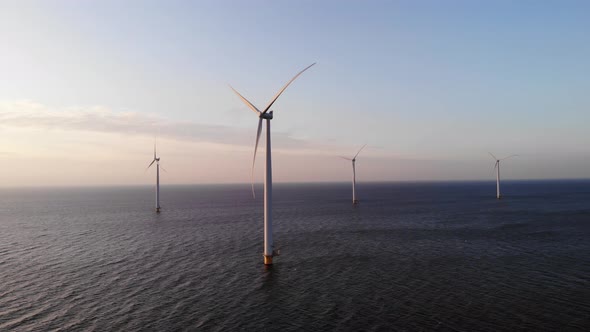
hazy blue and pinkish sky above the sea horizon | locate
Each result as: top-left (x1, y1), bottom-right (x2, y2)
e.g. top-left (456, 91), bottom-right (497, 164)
top-left (0, 0), bottom-right (590, 187)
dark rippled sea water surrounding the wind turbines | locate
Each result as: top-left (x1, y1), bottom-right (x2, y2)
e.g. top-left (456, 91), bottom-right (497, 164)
top-left (0, 181), bottom-right (590, 331)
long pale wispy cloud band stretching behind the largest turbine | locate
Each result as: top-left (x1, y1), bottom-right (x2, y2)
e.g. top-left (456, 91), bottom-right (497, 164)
top-left (0, 101), bottom-right (311, 149)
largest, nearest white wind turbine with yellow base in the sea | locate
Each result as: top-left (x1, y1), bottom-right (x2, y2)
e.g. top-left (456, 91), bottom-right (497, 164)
top-left (230, 62), bottom-right (315, 265)
